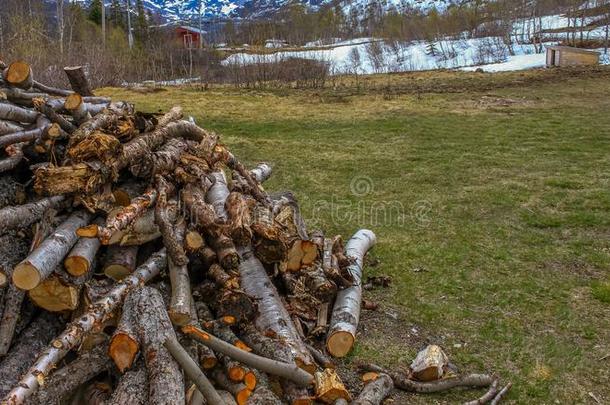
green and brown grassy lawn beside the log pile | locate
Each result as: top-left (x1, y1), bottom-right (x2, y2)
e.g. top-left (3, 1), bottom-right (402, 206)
top-left (101, 69), bottom-right (610, 404)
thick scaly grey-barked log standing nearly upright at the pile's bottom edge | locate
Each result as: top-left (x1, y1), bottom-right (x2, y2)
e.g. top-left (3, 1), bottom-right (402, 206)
top-left (131, 287), bottom-right (184, 405)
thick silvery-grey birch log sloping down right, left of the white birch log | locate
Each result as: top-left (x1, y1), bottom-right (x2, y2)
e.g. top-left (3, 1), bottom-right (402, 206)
top-left (239, 251), bottom-right (316, 373)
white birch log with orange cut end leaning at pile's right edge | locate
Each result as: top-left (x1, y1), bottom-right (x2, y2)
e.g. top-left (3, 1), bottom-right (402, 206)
top-left (326, 229), bottom-right (376, 357)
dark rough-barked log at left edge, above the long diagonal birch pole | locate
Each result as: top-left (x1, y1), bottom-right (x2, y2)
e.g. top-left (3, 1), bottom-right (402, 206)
top-left (0, 313), bottom-right (63, 396)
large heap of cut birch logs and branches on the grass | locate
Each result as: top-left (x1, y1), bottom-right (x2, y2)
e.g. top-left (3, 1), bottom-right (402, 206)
top-left (0, 62), bottom-right (506, 405)
